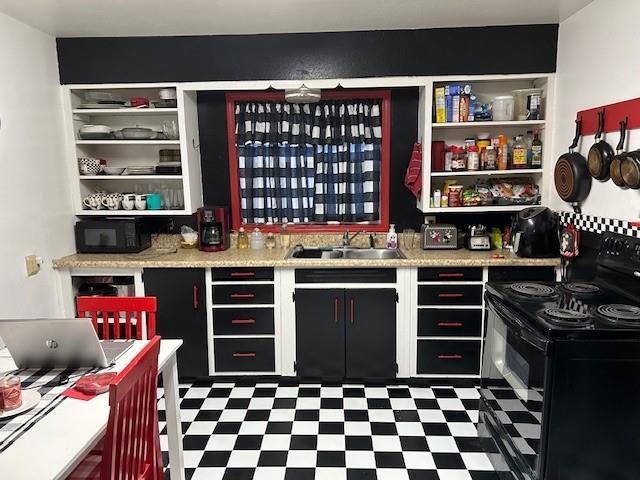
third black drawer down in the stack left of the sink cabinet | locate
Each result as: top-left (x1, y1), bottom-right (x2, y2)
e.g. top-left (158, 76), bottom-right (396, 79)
top-left (213, 308), bottom-right (273, 335)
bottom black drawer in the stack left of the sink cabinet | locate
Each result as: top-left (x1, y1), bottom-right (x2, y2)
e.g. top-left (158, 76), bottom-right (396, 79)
top-left (214, 338), bottom-right (276, 372)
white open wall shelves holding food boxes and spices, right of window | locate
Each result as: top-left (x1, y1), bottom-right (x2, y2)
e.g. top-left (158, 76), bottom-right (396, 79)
top-left (418, 73), bottom-right (555, 214)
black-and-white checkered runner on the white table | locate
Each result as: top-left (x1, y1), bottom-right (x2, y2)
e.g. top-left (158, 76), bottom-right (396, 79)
top-left (0, 369), bottom-right (94, 453)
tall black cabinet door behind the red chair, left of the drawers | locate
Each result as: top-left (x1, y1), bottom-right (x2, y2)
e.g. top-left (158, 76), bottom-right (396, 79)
top-left (144, 268), bottom-right (209, 378)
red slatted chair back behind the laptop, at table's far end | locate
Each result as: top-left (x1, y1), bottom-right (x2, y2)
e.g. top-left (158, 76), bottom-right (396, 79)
top-left (76, 297), bottom-right (158, 340)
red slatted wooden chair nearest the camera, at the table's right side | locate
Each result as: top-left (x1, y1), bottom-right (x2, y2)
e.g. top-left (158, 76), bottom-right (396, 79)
top-left (67, 336), bottom-right (164, 480)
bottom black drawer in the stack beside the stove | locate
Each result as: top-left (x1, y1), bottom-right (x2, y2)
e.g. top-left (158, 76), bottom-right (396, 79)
top-left (417, 340), bottom-right (480, 375)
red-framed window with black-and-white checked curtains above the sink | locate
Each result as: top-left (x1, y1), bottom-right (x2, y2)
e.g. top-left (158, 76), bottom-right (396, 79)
top-left (227, 90), bottom-right (391, 231)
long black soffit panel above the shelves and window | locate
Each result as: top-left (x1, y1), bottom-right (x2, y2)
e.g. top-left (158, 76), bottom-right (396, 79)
top-left (57, 24), bottom-right (558, 84)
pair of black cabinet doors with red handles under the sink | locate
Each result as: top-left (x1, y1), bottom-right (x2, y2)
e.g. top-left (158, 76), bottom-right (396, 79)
top-left (295, 288), bottom-right (396, 379)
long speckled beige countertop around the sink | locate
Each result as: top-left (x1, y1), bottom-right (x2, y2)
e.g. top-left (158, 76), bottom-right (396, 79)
top-left (53, 248), bottom-right (560, 269)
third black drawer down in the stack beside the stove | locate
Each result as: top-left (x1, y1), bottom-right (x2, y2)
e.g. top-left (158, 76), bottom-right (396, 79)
top-left (418, 308), bottom-right (482, 337)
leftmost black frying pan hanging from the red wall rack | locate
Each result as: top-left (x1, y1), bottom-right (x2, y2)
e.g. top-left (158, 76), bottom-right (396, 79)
top-left (553, 119), bottom-right (591, 204)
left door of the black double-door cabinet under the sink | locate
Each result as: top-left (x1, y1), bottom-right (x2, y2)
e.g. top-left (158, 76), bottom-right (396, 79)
top-left (295, 289), bottom-right (345, 378)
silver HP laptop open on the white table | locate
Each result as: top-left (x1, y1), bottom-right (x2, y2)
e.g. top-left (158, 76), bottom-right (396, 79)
top-left (0, 318), bottom-right (133, 368)
